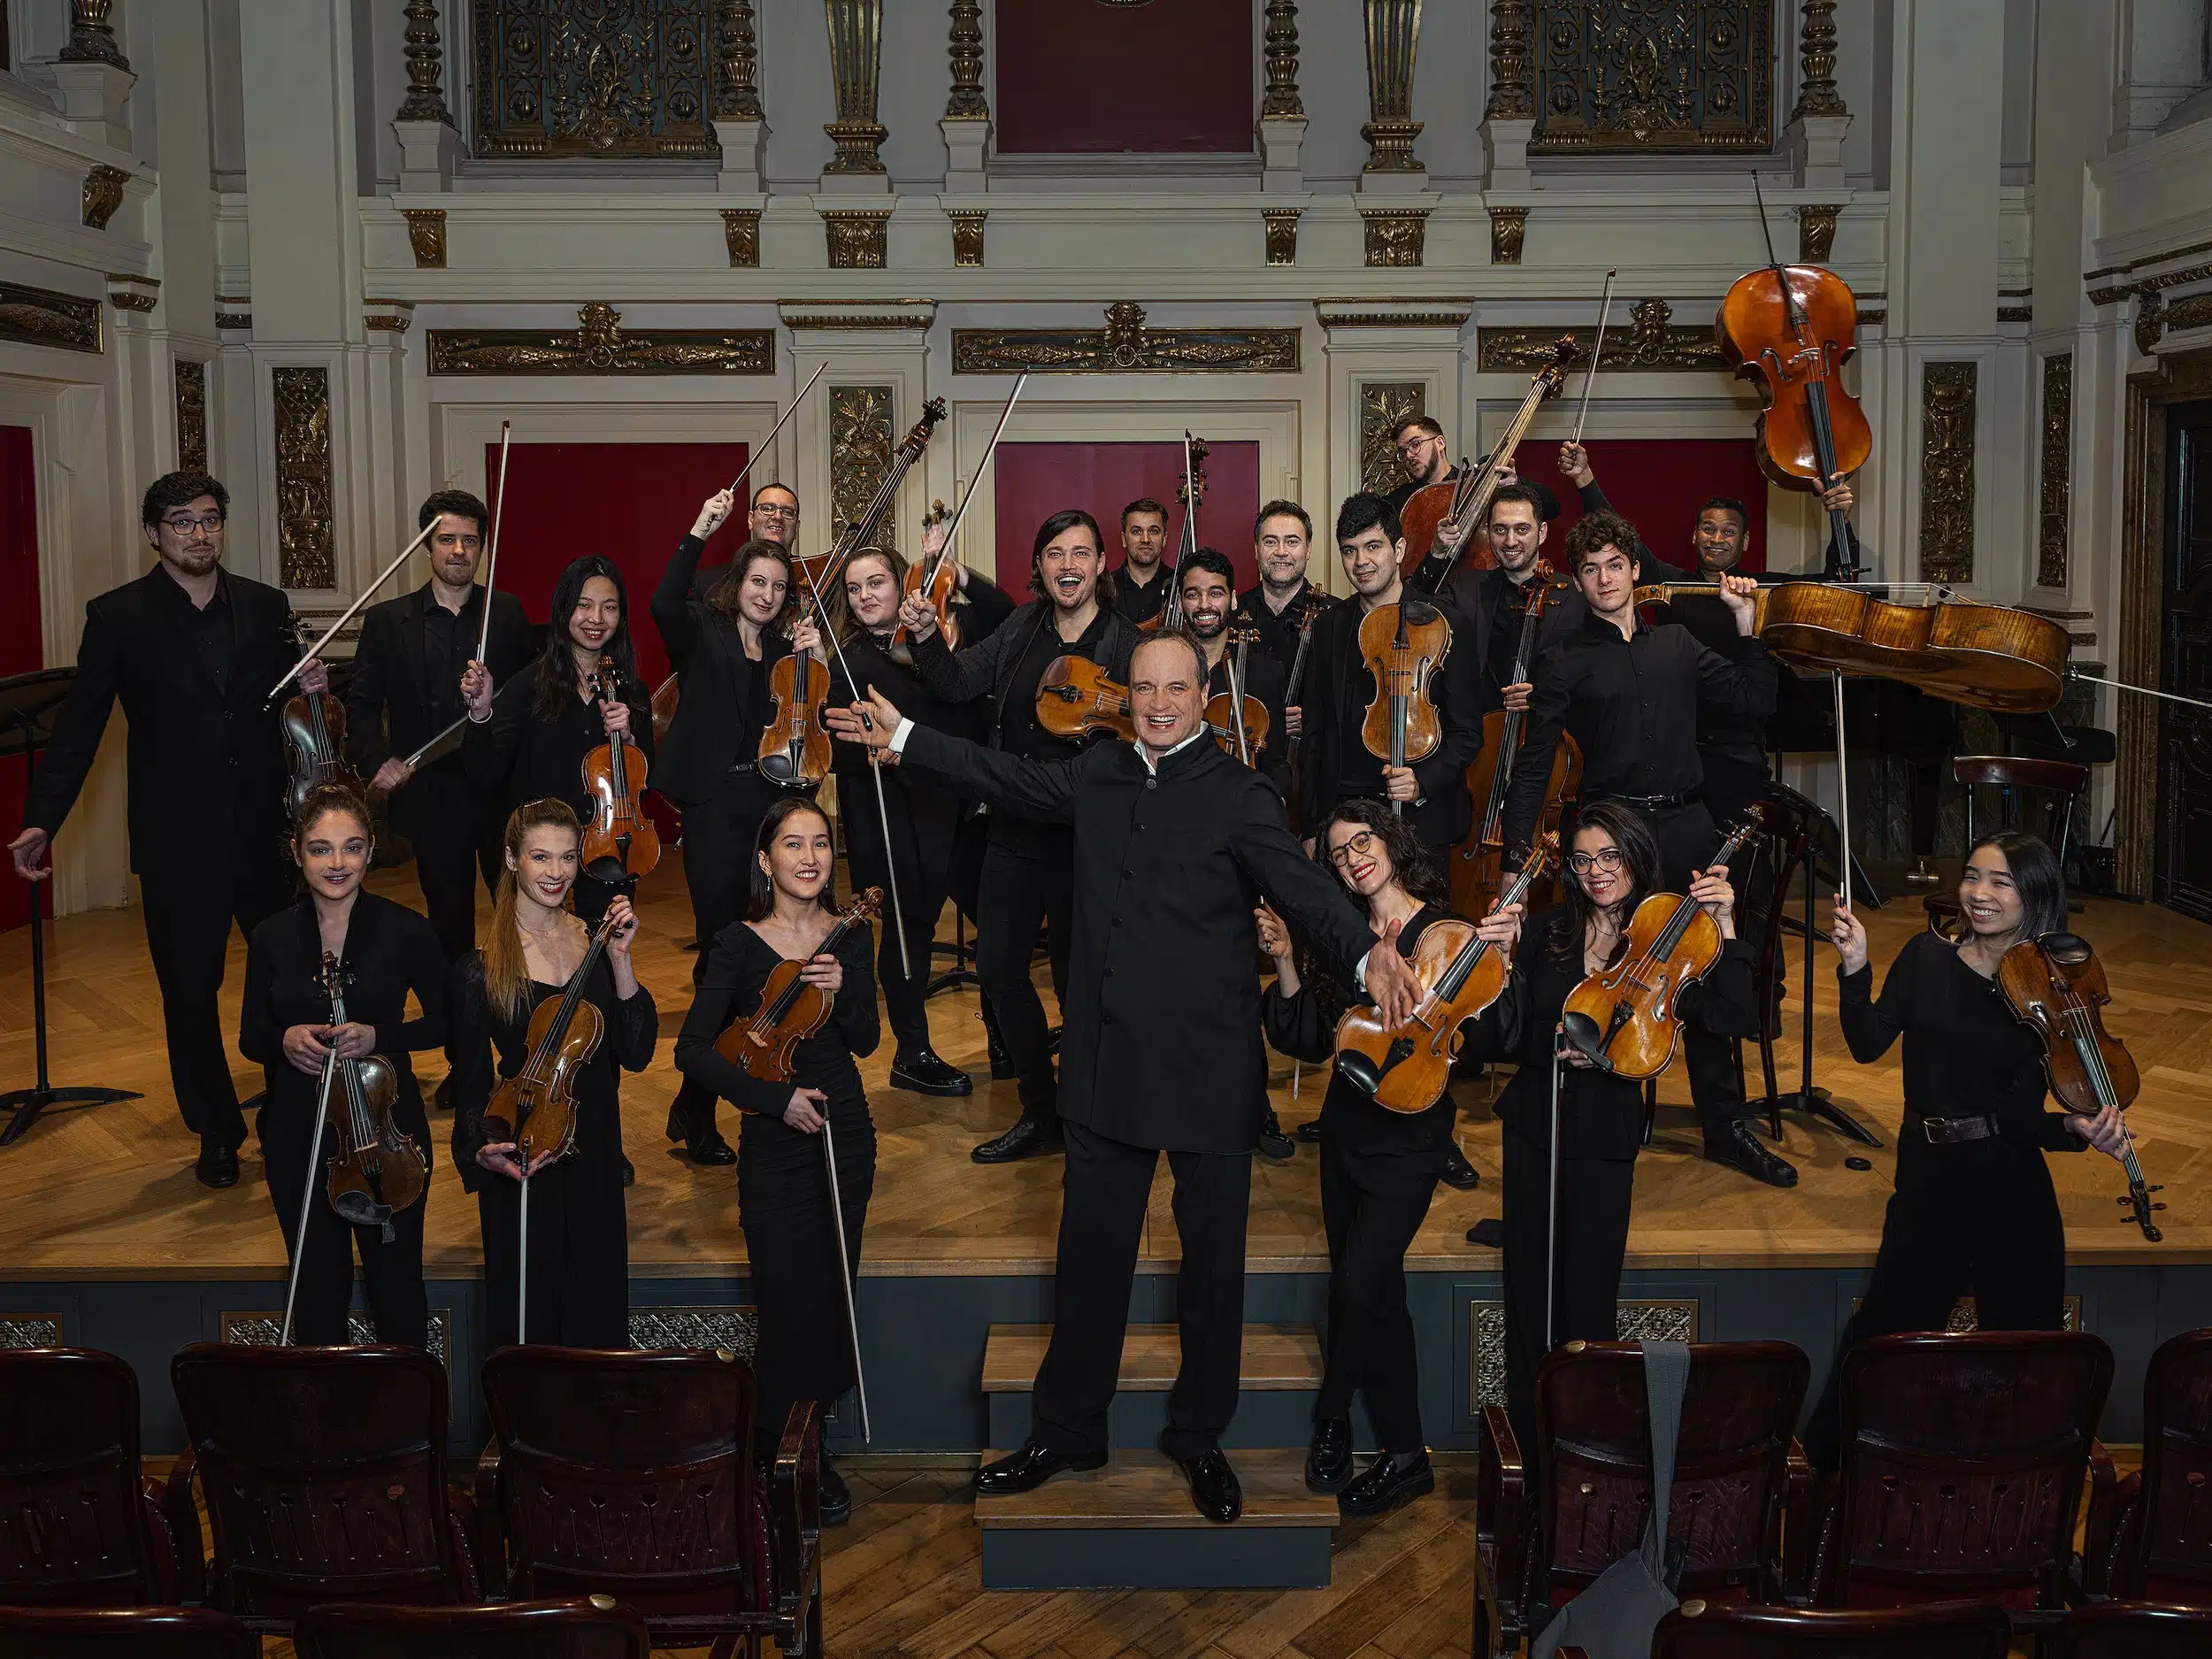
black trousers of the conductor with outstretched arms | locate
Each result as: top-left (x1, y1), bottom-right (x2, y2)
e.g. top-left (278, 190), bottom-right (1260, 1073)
top-left (1031, 1124), bottom-right (1252, 1460)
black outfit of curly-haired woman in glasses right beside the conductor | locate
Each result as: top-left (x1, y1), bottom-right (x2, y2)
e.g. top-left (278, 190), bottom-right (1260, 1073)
top-left (1261, 905), bottom-right (1451, 1451)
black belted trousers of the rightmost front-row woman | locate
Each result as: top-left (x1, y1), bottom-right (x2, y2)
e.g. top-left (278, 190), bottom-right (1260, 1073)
top-left (1805, 1141), bottom-right (2066, 1471)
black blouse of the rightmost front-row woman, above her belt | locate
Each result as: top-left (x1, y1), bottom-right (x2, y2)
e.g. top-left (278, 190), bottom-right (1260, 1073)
top-left (1836, 933), bottom-right (2088, 1153)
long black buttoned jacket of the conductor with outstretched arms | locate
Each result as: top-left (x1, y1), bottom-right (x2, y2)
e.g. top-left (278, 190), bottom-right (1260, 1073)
top-left (905, 726), bottom-right (1374, 1157)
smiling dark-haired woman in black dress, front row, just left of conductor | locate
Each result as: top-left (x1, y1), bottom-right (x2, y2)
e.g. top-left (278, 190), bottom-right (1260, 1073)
top-left (677, 796), bottom-right (883, 1525)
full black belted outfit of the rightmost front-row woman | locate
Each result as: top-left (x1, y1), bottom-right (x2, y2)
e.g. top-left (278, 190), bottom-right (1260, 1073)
top-left (1805, 933), bottom-right (2088, 1469)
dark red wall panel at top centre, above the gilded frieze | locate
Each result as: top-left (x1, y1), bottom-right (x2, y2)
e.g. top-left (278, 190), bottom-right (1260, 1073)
top-left (991, 0), bottom-right (1256, 155)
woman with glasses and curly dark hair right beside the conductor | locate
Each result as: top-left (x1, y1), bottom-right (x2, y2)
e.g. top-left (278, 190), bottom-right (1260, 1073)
top-left (1259, 801), bottom-right (1520, 1516)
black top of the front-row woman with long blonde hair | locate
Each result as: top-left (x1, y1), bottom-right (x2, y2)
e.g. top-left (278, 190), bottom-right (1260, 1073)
top-left (451, 951), bottom-right (662, 1193)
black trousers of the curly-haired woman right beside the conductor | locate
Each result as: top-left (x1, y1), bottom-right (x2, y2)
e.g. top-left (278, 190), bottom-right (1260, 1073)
top-left (1314, 1122), bottom-right (1436, 1451)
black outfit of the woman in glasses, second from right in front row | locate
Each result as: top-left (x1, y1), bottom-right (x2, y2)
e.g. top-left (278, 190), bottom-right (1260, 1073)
top-left (1464, 910), bottom-right (1759, 1445)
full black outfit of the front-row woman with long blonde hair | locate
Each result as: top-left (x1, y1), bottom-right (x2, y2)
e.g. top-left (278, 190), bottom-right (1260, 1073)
top-left (451, 951), bottom-right (659, 1349)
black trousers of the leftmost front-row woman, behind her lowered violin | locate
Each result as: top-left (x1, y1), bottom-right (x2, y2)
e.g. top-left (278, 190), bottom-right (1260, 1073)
top-left (261, 1087), bottom-right (432, 1348)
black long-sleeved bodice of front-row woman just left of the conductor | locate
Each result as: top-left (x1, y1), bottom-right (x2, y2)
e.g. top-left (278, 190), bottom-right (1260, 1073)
top-left (677, 923), bottom-right (883, 1118)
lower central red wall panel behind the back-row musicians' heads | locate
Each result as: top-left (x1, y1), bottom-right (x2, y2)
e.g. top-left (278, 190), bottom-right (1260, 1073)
top-left (991, 442), bottom-right (1259, 600)
